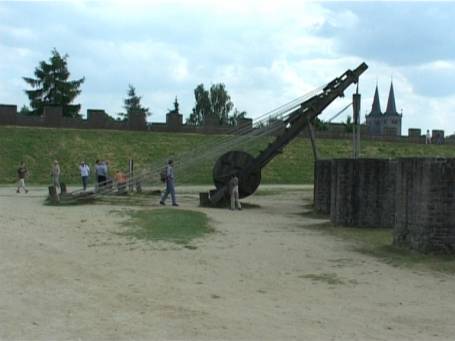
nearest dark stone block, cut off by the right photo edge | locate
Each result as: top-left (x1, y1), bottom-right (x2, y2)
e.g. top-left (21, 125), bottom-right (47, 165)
top-left (394, 158), bottom-right (455, 253)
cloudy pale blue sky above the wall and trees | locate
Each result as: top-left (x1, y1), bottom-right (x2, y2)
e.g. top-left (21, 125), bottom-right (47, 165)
top-left (0, 0), bottom-right (455, 135)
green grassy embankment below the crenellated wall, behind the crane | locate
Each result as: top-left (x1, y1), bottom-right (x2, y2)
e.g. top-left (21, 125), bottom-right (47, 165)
top-left (0, 127), bottom-right (455, 185)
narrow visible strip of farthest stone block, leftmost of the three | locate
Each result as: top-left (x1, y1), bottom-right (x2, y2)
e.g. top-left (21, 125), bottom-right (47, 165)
top-left (314, 160), bottom-right (333, 214)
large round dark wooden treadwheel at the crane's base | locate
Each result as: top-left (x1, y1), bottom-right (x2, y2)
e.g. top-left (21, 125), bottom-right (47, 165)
top-left (213, 151), bottom-right (261, 198)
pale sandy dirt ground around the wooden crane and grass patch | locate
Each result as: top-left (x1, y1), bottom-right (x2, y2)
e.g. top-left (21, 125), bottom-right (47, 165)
top-left (0, 186), bottom-right (455, 340)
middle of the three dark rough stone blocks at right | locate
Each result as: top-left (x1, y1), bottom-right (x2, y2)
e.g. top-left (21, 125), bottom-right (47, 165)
top-left (330, 159), bottom-right (396, 228)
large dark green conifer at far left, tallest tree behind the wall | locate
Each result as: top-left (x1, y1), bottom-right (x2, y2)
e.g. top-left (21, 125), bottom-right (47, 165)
top-left (23, 49), bottom-right (85, 117)
